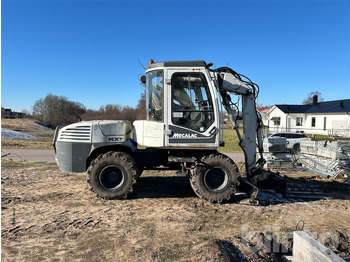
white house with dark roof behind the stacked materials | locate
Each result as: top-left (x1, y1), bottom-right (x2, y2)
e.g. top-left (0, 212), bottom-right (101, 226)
top-left (265, 97), bottom-right (350, 137)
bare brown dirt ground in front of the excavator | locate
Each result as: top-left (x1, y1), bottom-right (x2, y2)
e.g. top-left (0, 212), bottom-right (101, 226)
top-left (1, 160), bottom-right (350, 261)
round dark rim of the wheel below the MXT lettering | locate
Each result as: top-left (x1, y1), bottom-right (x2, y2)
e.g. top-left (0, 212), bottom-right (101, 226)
top-left (99, 165), bottom-right (125, 189)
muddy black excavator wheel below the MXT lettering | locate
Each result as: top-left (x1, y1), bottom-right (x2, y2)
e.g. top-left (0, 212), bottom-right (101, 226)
top-left (86, 152), bottom-right (140, 199)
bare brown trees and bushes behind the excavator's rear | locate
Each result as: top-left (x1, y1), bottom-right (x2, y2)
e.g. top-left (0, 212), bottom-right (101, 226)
top-left (33, 94), bottom-right (146, 128)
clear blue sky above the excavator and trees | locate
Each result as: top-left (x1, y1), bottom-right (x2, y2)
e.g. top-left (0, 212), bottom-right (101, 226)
top-left (1, 0), bottom-right (350, 111)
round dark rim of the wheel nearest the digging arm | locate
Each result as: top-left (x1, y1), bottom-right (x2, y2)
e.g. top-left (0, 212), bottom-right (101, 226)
top-left (204, 167), bottom-right (228, 191)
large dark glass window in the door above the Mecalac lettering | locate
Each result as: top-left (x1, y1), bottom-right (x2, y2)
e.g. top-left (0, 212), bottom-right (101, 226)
top-left (171, 73), bottom-right (214, 132)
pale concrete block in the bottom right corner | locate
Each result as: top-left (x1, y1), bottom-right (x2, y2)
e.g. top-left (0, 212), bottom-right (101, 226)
top-left (293, 231), bottom-right (345, 262)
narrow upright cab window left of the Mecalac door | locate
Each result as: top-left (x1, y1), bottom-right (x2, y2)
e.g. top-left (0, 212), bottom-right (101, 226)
top-left (146, 70), bottom-right (164, 122)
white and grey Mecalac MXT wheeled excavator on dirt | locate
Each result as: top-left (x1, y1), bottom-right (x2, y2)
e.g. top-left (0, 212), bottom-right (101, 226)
top-left (54, 60), bottom-right (286, 203)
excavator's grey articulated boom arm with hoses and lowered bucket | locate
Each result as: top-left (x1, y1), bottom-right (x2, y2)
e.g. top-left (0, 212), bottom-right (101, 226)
top-left (212, 67), bottom-right (286, 193)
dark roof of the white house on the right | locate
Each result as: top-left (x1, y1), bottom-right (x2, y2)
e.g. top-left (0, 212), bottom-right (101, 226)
top-left (275, 99), bottom-right (350, 114)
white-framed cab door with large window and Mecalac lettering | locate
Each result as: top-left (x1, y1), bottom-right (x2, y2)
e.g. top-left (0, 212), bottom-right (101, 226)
top-left (167, 69), bottom-right (218, 147)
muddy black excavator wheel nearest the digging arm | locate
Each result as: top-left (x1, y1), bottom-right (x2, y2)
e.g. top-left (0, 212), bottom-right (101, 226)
top-left (190, 153), bottom-right (239, 203)
